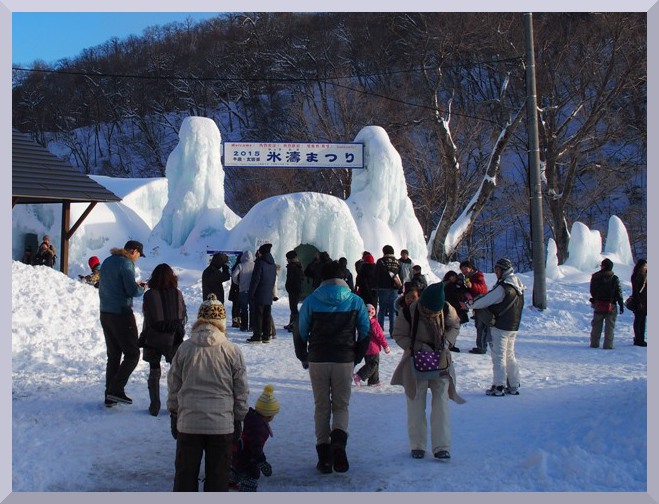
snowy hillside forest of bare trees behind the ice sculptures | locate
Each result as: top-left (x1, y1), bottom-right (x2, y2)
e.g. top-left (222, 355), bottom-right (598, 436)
top-left (12, 12), bottom-right (647, 270)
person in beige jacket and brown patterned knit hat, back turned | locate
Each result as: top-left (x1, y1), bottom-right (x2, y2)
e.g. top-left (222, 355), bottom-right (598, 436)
top-left (167, 294), bottom-right (249, 492)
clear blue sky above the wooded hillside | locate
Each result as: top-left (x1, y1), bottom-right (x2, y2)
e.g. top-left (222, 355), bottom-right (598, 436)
top-left (11, 12), bottom-right (219, 65)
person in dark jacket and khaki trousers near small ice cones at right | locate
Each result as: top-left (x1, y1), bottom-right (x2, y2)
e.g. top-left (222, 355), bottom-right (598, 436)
top-left (590, 258), bottom-right (625, 350)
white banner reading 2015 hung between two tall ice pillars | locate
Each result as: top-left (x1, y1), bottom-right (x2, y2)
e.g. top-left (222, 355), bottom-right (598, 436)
top-left (224, 142), bottom-right (364, 169)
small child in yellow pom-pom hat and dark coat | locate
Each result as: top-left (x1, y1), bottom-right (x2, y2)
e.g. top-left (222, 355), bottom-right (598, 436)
top-left (230, 385), bottom-right (279, 492)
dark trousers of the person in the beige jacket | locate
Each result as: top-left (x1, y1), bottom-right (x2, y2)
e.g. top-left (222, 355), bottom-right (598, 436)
top-left (174, 432), bottom-right (233, 492)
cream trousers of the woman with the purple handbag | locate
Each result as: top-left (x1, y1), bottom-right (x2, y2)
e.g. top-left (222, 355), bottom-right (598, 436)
top-left (406, 376), bottom-right (451, 454)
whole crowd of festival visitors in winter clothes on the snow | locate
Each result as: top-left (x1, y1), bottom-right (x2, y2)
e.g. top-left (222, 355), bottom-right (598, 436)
top-left (50, 236), bottom-right (647, 491)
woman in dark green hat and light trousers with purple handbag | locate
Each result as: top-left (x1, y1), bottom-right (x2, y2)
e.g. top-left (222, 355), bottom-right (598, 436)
top-left (391, 282), bottom-right (465, 461)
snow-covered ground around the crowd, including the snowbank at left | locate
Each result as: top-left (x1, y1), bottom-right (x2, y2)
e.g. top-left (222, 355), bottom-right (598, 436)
top-left (12, 257), bottom-right (653, 499)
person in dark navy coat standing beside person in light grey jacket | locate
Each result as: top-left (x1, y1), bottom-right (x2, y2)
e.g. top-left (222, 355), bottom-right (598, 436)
top-left (247, 243), bottom-right (277, 343)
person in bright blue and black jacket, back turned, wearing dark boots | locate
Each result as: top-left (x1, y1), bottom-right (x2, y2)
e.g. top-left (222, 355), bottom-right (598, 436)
top-left (293, 261), bottom-right (371, 473)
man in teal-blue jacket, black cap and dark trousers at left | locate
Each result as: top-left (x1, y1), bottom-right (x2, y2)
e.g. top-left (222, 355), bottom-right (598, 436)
top-left (98, 240), bottom-right (146, 407)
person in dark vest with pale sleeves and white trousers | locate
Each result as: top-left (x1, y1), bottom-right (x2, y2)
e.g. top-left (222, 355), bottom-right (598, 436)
top-left (469, 258), bottom-right (526, 397)
